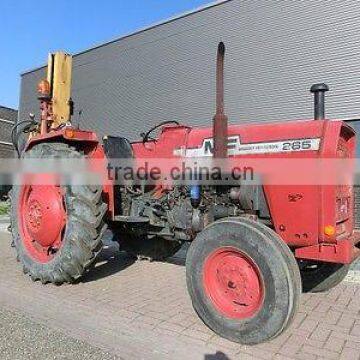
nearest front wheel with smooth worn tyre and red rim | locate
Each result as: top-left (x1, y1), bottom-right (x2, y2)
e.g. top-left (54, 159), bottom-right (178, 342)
top-left (186, 218), bottom-right (301, 344)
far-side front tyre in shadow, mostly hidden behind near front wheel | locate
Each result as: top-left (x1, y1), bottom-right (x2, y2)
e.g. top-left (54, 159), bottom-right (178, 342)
top-left (299, 260), bottom-right (350, 293)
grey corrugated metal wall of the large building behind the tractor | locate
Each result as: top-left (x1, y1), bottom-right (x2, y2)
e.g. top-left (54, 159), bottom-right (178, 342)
top-left (20, 0), bottom-right (360, 140)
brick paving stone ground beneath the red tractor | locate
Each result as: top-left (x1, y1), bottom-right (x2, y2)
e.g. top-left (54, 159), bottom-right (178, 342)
top-left (0, 233), bottom-right (360, 360)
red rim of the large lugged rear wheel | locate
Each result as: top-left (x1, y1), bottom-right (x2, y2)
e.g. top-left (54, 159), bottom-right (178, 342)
top-left (18, 185), bottom-right (66, 263)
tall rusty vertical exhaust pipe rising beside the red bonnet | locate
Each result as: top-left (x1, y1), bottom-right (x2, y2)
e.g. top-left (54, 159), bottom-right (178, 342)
top-left (213, 42), bottom-right (228, 159)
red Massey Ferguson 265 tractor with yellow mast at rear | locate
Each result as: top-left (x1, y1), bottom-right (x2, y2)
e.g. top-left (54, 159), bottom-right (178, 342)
top-left (11, 43), bottom-right (360, 344)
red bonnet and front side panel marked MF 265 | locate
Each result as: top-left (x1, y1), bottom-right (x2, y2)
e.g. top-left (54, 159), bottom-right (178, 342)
top-left (133, 120), bottom-right (354, 247)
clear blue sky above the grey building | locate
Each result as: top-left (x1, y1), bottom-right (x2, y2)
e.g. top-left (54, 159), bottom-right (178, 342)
top-left (0, 0), bottom-right (211, 108)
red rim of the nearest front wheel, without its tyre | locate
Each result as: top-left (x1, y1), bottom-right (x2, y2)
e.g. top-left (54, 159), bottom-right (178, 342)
top-left (203, 247), bottom-right (264, 319)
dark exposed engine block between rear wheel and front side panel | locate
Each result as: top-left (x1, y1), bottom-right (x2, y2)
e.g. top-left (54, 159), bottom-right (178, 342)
top-left (115, 185), bottom-right (270, 241)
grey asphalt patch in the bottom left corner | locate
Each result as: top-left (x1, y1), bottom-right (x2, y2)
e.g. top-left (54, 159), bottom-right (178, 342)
top-left (0, 309), bottom-right (121, 360)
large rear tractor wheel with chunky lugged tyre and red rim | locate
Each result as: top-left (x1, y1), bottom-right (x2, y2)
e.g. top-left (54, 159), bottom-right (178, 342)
top-left (11, 143), bottom-right (107, 285)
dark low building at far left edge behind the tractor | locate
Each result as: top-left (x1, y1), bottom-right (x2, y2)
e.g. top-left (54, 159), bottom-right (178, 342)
top-left (0, 106), bottom-right (18, 158)
